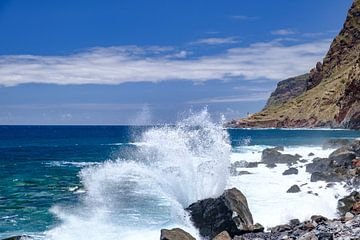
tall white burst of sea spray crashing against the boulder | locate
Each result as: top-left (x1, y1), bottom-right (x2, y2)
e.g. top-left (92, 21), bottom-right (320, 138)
top-left (46, 110), bottom-right (231, 240)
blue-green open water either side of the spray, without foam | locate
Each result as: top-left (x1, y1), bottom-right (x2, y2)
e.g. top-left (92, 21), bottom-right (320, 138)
top-left (0, 126), bottom-right (360, 237)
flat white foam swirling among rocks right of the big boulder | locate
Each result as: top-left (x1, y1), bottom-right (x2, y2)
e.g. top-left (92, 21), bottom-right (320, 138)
top-left (229, 146), bottom-right (346, 227)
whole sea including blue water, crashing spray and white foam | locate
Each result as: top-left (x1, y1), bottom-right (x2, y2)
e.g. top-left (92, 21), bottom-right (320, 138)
top-left (0, 111), bottom-right (360, 240)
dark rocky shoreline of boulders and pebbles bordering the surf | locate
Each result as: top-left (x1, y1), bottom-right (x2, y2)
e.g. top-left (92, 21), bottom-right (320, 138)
top-left (3, 139), bottom-right (360, 240)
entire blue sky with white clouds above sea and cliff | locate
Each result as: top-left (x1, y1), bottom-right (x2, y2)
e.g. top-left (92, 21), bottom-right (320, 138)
top-left (0, 0), bottom-right (352, 125)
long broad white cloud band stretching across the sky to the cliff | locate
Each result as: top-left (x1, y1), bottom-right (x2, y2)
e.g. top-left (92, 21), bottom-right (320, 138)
top-left (0, 40), bottom-right (330, 86)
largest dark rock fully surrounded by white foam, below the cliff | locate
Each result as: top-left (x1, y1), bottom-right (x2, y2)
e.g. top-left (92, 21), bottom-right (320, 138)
top-left (261, 148), bottom-right (300, 165)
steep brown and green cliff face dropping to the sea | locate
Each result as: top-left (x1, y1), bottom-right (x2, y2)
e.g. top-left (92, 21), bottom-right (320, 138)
top-left (229, 0), bottom-right (360, 129)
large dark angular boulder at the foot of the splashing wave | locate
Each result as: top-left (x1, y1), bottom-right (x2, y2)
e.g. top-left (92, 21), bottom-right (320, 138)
top-left (186, 188), bottom-right (254, 238)
